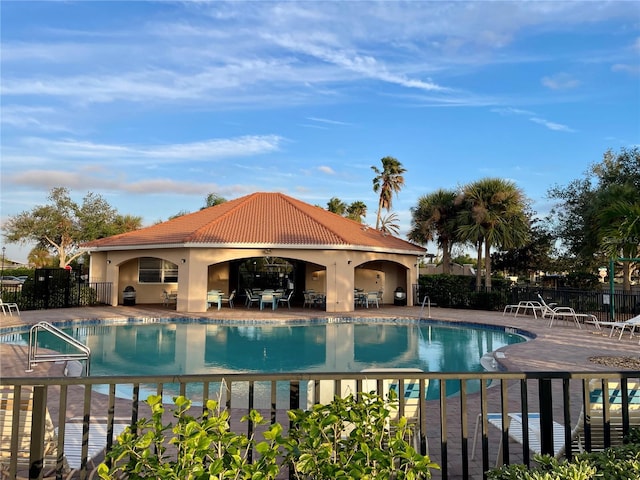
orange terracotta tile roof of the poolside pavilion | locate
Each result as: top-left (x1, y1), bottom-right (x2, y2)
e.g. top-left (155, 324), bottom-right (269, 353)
top-left (83, 192), bottom-right (424, 253)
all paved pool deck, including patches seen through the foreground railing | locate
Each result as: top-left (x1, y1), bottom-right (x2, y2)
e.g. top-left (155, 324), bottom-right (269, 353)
top-left (0, 305), bottom-right (640, 479)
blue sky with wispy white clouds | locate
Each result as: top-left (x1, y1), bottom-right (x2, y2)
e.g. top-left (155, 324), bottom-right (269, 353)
top-left (0, 0), bottom-right (640, 261)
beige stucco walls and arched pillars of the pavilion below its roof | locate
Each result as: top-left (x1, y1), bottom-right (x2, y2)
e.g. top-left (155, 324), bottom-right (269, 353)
top-left (90, 248), bottom-right (417, 313)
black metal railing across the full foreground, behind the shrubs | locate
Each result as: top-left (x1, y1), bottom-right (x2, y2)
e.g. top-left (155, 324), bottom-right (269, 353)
top-left (0, 371), bottom-right (640, 479)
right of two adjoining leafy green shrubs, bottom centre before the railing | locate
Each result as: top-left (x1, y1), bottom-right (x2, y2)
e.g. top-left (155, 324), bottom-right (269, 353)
top-left (284, 392), bottom-right (438, 480)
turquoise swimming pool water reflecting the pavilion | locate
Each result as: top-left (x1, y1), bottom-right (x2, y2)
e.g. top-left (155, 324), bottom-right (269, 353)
top-left (0, 322), bottom-right (522, 404)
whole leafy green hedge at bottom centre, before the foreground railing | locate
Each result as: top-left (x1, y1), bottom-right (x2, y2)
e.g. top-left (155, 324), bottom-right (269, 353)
top-left (98, 394), bottom-right (438, 480)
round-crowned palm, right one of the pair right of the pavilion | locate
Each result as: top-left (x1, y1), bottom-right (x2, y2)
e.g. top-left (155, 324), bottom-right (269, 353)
top-left (458, 178), bottom-right (529, 290)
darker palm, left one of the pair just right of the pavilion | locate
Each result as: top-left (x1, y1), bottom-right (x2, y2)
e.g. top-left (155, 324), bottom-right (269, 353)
top-left (408, 188), bottom-right (459, 273)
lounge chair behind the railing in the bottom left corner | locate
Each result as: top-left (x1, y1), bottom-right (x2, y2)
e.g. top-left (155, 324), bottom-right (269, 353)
top-left (0, 387), bottom-right (126, 479)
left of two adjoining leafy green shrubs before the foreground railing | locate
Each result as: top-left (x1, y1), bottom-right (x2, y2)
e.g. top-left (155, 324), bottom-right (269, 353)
top-left (98, 395), bottom-right (282, 480)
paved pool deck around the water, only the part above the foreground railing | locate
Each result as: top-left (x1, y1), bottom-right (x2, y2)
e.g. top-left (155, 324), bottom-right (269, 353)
top-left (0, 305), bottom-right (640, 377)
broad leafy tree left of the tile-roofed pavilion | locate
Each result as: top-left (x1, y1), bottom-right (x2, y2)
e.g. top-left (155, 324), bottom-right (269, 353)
top-left (2, 187), bottom-right (142, 267)
